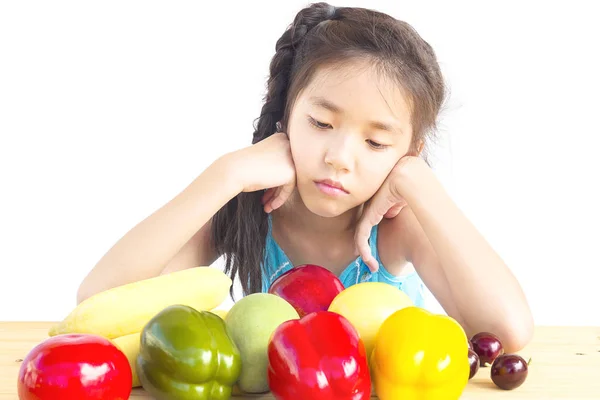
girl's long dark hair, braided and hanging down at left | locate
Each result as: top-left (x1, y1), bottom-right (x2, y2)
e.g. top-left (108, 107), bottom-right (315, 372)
top-left (211, 3), bottom-right (447, 295)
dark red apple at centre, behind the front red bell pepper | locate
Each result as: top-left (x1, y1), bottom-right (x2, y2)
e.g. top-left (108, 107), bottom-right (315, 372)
top-left (269, 264), bottom-right (344, 317)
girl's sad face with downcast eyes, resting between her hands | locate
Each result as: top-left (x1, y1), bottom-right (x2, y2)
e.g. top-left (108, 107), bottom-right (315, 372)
top-left (288, 63), bottom-right (412, 217)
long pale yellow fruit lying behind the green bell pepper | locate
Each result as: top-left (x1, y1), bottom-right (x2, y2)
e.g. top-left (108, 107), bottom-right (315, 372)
top-left (48, 267), bottom-right (232, 339)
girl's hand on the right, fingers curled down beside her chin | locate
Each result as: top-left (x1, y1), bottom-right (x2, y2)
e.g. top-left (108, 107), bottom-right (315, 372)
top-left (354, 155), bottom-right (428, 272)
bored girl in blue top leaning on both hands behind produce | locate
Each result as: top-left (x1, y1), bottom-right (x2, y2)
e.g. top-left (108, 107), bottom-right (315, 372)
top-left (78, 3), bottom-right (533, 352)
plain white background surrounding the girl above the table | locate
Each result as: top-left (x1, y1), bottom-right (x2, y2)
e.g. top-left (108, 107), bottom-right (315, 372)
top-left (0, 0), bottom-right (600, 325)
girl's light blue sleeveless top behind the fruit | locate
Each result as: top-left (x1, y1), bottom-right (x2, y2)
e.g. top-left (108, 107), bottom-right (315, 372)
top-left (261, 214), bottom-right (425, 307)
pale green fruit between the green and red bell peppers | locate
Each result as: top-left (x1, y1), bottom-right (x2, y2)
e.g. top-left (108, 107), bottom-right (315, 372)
top-left (225, 293), bottom-right (299, 393)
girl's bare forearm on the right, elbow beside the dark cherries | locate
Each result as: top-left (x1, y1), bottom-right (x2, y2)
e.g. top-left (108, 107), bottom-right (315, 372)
top-left (403, 173), bottom-right (533, 350)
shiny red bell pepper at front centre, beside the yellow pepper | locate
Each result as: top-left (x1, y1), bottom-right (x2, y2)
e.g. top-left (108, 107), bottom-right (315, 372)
top-left (267, 311), bottom-right (371, 400)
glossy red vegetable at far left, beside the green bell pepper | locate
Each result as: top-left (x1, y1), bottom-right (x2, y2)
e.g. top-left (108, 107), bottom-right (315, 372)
top-left (17, 334), bottom-right (132, 400)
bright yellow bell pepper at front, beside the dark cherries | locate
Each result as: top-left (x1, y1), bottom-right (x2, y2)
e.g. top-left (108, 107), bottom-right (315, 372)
top-left (370, 307), bottom-right (469, 400)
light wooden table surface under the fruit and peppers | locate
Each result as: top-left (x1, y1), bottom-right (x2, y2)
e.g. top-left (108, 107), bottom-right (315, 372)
top-left (0, 322), bottom-right (600, 400)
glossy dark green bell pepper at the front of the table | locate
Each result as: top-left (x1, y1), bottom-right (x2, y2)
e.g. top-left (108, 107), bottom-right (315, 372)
top-left (136, 305), bottom-right (242, 400)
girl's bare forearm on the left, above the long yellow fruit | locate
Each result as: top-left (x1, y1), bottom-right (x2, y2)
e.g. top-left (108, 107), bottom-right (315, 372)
top-left (77, 155), bottom-right (241, 302)
